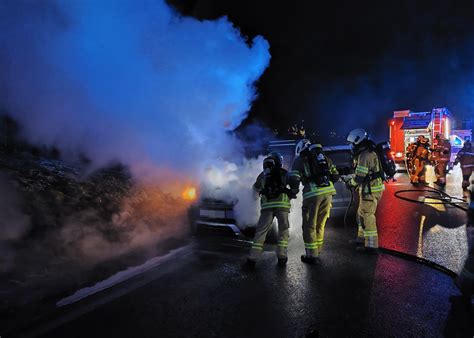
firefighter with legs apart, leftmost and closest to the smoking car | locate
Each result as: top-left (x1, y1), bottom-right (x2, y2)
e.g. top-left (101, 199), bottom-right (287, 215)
top-left (247, 152), bottom-right (298, 266)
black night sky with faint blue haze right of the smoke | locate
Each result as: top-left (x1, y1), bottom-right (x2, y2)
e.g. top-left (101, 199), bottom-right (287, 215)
top-left (169, 0), bottom-right (474, 140)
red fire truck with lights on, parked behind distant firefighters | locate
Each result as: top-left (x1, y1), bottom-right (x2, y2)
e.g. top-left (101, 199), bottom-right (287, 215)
top-left (389, 108), bottom-right (472, 164)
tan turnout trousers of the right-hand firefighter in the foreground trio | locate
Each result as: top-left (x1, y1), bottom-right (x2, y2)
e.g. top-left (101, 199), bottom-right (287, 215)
top-left (357, 191), bottom-right (382, 248)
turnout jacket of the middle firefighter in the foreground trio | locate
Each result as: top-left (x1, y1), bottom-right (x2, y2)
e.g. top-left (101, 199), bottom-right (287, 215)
top-left (290, 156), bottom-right (337, 200)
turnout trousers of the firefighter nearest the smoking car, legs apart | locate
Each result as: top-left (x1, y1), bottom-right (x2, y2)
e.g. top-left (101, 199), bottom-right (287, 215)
top-left (249, 209), bottom-right (290, 260)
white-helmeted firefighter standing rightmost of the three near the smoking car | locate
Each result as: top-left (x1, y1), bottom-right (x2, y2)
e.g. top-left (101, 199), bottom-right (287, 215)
top-left (347, 129), bottom-right (385, 254)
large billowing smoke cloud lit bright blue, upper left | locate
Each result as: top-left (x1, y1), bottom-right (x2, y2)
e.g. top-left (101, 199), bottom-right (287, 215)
top-left (0, 0), bottom-right (270, 182)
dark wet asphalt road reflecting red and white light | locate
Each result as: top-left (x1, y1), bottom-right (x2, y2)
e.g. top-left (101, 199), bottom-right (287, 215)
top-left (25, 172), bottom-right (474, 337)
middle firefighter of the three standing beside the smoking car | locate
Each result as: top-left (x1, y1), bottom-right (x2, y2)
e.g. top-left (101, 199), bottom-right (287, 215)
top-left (290, 140), bottom-right (339, 264)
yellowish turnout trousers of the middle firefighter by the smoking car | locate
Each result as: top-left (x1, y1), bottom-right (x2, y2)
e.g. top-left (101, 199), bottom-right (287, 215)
top-left (302, 194), bottom-right (332, 257)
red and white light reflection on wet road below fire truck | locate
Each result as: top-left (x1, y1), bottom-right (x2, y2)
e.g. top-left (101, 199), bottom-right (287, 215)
top-left (377, 168), bottom-right (468, 273)
